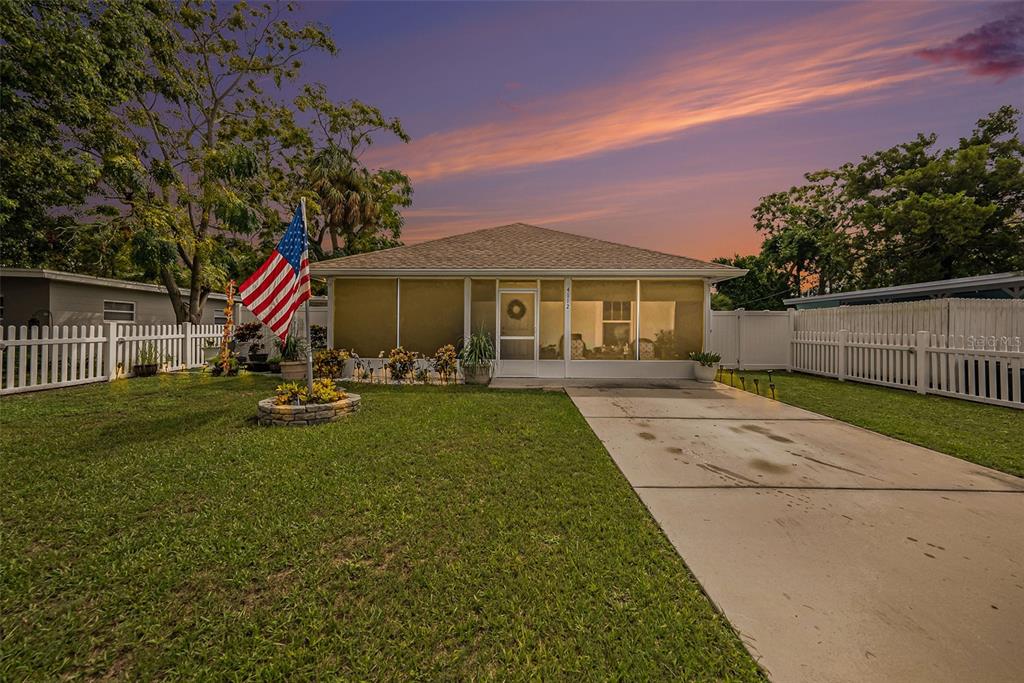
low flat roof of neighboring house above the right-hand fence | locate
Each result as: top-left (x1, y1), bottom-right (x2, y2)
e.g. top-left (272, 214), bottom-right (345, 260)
top-left (783, 271), bottom-right (1024, 309)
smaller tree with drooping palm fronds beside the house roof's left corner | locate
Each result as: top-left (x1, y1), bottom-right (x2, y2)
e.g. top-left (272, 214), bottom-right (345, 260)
top-left (296, 86), bottom-right (413, 256)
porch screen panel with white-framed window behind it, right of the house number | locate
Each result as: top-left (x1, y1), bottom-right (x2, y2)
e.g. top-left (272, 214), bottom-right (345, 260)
top-left (570, 280), bottom-right (637, 360)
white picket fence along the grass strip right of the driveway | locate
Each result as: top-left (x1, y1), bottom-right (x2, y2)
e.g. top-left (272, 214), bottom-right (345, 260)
top-left (786, 330), bottom-right (1024, 409)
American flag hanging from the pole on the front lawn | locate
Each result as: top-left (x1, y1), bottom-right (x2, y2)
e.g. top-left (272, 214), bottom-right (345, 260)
top-left (239, 206), bottom-right (310, 341)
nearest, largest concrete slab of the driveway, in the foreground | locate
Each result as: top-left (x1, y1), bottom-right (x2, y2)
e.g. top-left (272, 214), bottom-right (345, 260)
top-left (639, 489), bottom-right (1024, 681)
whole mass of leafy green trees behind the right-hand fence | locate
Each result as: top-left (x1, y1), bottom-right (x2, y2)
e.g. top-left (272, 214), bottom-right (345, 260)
top-left (723, 106), bottom-right (1024, 298)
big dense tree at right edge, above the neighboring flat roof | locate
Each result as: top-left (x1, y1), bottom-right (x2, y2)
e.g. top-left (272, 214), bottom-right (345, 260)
top-left (836, 106), bottom-right (1024, 287)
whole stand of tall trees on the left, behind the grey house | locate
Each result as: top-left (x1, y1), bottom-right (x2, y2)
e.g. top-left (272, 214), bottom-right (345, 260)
top-left (0, 0), bottom-right (412, 322)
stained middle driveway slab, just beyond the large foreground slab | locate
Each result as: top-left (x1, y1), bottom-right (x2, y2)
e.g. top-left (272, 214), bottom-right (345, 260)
top-left (588, 417), bottom-right (1024, 492)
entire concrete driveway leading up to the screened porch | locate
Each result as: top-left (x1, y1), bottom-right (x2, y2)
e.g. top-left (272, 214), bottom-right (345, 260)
top-left (566, 383), bottom-right (1024, 681)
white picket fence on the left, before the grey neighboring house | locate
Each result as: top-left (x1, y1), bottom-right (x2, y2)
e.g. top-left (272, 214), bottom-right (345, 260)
top-left (0, 323), bottom-right (223, 394)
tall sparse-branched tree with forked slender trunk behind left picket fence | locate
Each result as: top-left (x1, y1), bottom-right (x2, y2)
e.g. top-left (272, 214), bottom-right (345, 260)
top-left (109, 0), bottom-right (335, 322)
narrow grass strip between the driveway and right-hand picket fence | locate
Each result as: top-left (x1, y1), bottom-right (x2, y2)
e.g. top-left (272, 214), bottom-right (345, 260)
top-left (722, 372), bottom-right (1024, 476)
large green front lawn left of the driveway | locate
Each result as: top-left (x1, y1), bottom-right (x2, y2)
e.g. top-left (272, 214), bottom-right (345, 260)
top-left (0, 375), bottom-right (761, 680)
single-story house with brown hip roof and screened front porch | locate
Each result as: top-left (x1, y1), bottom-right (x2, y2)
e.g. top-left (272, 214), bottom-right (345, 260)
top-left (310, 223), bottom-right (745, 378)
